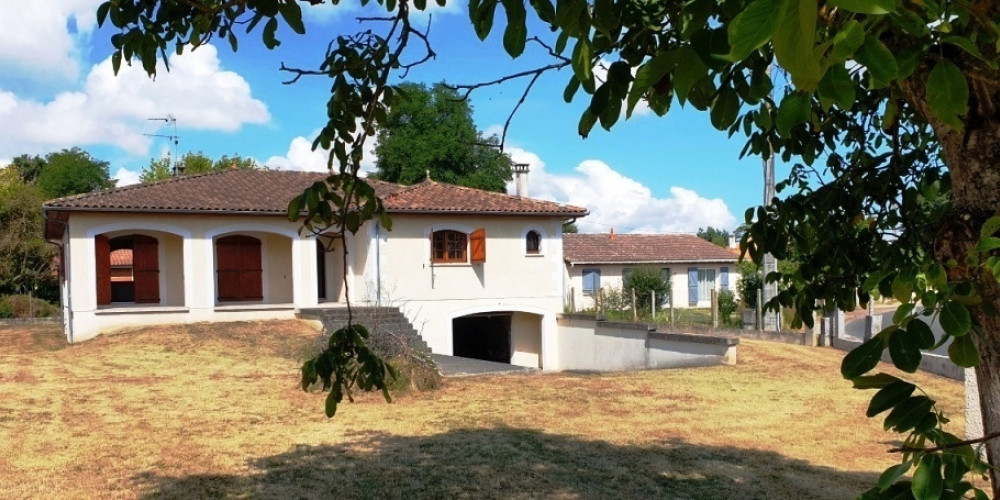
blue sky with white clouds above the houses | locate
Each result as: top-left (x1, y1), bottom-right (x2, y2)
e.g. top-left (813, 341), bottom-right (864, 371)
top-left (0, 0), bottom-right (787, 232)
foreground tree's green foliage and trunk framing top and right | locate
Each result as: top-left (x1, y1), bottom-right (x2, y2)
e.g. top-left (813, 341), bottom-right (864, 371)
top-left (98, 0), bottom-right (1000, 499)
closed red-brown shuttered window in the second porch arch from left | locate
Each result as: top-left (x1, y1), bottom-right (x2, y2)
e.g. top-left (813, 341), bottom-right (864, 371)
top-left (215, 235), bottom-right (264, 302)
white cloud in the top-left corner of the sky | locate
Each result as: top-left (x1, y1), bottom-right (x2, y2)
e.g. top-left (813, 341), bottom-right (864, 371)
top-left (0, 0), bottom-right (102, 80)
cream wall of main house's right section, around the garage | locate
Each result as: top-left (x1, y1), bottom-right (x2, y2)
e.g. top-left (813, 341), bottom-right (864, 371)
top-left (368, 214), bottom-right (565, 366)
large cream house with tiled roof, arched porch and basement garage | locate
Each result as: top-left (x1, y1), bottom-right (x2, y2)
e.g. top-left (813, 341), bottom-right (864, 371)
top-left (45, 170), bottom-right (587, 367)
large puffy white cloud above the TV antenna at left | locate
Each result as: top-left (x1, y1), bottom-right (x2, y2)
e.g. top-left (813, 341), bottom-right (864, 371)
top-left (0, 45), bottom-right (270, 156)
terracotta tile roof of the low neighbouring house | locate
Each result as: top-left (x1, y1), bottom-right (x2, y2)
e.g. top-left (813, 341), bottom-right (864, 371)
top-left (563, 233), bottom-right (739, 264)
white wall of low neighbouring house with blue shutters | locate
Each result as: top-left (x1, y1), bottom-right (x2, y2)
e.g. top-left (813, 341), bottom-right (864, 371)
top-left (565, 262), bottom-right (740, 311)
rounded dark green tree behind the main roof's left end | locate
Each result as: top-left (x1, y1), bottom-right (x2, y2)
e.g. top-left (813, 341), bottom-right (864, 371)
top-left (38, 148), bottom-right (115, 198)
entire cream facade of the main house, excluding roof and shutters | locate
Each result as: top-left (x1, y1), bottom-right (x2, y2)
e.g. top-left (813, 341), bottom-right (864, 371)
top-left (54, 211), bottom-right (565, 368)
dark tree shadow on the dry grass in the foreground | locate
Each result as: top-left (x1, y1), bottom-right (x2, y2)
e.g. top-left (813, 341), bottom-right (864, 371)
top-left (134, 427), bottom-right (877, 499)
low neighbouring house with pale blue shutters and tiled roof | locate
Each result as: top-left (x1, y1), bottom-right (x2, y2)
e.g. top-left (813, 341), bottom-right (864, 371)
top-left (563, 230), bottom-right (739, 311)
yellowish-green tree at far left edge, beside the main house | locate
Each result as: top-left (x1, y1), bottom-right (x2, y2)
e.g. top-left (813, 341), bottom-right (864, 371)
top-left (0, 168), bottom-right (58, 299)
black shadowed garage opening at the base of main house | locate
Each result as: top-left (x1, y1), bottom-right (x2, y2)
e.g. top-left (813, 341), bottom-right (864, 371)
top-left (451, 313), bottom-right (512, 364)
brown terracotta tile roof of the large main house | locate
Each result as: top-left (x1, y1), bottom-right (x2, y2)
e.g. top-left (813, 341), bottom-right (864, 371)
top-left (45, 170), bottom-right (587, 217)
